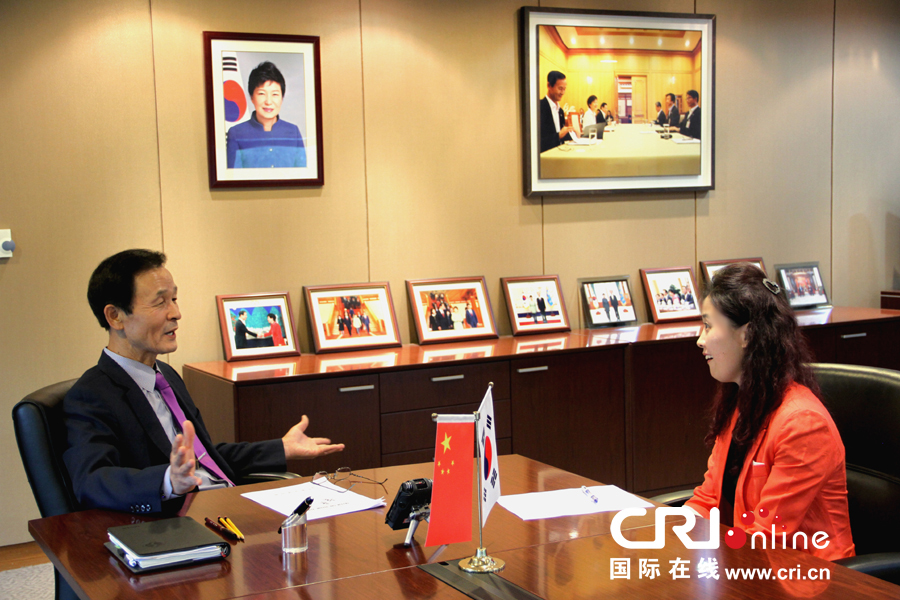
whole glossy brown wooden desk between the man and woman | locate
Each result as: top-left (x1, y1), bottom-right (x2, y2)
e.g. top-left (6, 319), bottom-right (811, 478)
top-left (28, 455), bottom-right (900, 600)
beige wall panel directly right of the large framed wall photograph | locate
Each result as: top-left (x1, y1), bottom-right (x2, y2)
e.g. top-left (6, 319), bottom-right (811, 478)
top-left (695, 0), bottom-right (833, 286)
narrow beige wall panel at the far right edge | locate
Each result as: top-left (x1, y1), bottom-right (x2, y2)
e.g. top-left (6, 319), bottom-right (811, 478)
top-left (830, 0), bottom-right (900, 306)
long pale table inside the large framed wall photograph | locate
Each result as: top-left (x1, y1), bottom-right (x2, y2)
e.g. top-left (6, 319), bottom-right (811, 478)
top-left (540, 124), bottom-right (700, 179)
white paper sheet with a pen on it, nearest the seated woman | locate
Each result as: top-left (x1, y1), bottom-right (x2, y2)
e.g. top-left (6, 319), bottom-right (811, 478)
top-left (498, 485), bottom-right (653, 521)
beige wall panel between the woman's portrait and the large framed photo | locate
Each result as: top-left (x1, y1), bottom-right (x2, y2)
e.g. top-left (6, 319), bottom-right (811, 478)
top-left (362, 0), bottom-right (542, 342)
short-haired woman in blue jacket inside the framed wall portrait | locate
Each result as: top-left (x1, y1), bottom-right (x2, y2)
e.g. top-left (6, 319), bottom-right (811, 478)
top-left (225, 61), bottom-right (306, 169)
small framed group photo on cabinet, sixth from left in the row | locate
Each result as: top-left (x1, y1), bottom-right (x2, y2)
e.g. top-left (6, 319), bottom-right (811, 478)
top-left (641, 267), bottom-right (700, 323)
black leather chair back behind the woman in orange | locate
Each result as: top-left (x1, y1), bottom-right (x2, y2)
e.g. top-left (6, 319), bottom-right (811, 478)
top-left (812, 364), bottom-right (900, 555)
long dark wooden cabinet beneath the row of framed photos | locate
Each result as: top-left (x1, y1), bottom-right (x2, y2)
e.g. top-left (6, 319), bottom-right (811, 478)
top-left (184, 308), bottom-right (900, 495)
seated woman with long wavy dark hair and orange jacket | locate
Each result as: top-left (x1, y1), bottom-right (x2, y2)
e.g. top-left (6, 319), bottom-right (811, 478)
top-left (686, 263), bottom-right (855, 560)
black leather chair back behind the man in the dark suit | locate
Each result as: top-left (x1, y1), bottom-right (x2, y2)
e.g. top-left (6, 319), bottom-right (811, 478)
top-left (13, 379), bottom-right (78, 517)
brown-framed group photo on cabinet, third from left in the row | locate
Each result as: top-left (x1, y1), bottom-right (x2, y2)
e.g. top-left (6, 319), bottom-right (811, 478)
top-left (406, 277), bottom-right (499, 344)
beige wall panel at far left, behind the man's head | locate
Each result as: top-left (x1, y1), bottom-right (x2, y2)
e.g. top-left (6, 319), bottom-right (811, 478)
top-left (0, 0), bottom-right (162, 545)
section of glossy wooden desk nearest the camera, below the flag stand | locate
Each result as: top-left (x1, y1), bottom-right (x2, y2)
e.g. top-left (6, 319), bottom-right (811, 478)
top-left (248, 520), bottom-right (900, 600)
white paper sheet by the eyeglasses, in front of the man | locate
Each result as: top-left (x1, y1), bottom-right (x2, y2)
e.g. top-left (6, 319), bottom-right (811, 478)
top-left (241, 481), bottom-right (385, 521)
